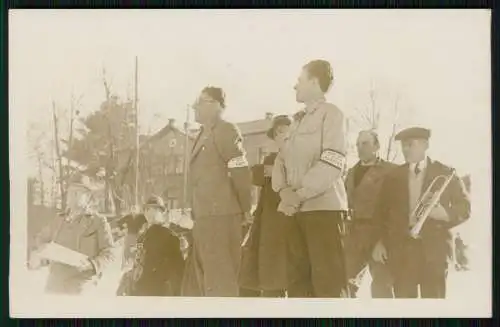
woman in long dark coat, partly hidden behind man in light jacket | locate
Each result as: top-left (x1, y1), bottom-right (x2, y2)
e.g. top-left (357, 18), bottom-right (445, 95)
top-left (240, 116), bottom-right (291, 297)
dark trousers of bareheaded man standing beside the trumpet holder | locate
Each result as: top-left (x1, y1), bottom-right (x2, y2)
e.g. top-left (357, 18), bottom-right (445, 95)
top-left (344, 219), bottom-right (394, 298)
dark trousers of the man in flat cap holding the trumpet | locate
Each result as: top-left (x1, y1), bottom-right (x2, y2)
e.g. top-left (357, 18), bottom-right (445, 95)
top-left (389, 240), bottom-right (448, 299)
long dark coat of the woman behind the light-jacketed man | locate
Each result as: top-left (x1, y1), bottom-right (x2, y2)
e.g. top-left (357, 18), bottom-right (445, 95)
top-left (240, 153), bottom-right (286, 290)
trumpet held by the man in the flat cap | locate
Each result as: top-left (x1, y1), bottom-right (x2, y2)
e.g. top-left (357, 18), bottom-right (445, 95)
top-left (410, 169), bottom-right (456, 238)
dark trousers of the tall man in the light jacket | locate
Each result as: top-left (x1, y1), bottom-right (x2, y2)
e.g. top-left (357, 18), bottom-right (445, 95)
top-left (286, 211), bottom-right (347, 298)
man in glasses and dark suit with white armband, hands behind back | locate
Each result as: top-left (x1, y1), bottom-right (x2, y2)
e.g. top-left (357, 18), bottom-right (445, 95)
top-left (187, 87), bottom-right (252, 297)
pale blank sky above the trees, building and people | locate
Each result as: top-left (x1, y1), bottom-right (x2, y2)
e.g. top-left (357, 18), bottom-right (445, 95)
top-left (9, 10), bottom-right (490, 176)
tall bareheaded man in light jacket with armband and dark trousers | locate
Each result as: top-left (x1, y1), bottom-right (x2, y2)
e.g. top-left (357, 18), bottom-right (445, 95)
top-left (272, 60), bottom-right (348, 298)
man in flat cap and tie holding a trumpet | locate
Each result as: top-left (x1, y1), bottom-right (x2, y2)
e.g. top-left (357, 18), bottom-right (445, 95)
top-left (373, 127), bottom-right (470, 298)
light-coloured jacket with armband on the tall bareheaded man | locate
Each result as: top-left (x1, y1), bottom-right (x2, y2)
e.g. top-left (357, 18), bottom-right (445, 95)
top-left (272, 100), bottom-right (347, 211)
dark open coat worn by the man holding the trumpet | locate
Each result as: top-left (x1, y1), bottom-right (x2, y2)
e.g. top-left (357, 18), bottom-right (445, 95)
top-left (376, 159), bottom-right (470, 267)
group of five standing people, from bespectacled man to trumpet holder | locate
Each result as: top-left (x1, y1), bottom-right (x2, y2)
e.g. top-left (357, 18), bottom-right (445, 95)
top-left (183, 60), bottom-right (470, 298)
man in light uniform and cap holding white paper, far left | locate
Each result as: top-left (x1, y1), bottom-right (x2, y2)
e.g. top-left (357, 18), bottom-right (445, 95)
top-left (30, 174), bottom-right (116, 295)
